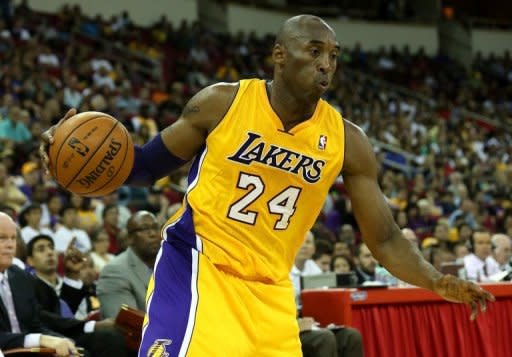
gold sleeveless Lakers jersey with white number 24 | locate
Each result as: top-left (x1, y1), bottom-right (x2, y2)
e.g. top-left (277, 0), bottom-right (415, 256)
top-left (169, 79), bottom-right (345, 282)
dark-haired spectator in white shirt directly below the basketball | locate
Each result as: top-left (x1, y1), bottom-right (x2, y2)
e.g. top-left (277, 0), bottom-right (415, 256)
top-left (55, 205), bottom-right (92, 253)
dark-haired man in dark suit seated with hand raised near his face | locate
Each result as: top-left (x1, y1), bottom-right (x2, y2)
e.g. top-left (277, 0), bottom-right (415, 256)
top-left (27, 235), bottom-right (128, 357)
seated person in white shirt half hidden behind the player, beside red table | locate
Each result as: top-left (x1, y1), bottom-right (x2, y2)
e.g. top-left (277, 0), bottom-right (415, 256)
top-left (290, 231), bottom-right (363, 357)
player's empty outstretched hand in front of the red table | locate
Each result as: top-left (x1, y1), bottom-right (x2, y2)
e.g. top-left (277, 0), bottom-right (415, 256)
top-left (434, 275), bottom-right (496, 320)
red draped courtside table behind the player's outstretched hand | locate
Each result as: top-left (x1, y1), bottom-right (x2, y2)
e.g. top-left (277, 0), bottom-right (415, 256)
top-left (302, 283), bottom-right (512, 357)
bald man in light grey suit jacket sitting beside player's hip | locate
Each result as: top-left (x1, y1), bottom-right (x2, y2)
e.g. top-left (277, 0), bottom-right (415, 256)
top-left (96, 211), bottom-right (161, 317)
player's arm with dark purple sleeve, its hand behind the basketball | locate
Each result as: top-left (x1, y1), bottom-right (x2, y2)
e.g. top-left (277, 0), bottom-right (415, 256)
top-left (39, 83), bottom-right (239, 179)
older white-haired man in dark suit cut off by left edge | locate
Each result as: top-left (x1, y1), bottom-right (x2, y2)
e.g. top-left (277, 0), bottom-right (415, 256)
top-left (0, 212), bottom-right (78, 356)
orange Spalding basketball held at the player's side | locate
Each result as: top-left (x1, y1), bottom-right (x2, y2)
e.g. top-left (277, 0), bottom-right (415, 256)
top-left (49, 112), bottom-right (134, 196)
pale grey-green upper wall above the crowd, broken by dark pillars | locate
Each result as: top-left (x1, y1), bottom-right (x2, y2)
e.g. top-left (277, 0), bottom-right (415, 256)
top-left (22, 0), bottom-right (512, 54)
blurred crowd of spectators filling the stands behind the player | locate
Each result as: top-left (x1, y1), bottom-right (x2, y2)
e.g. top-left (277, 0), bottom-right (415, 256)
top-left (0, 2), bottom-right (512, 324)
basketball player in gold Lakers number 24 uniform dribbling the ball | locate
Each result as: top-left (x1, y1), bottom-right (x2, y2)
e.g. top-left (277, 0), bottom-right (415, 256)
top-left (41, 15), bottom-right (493, 357)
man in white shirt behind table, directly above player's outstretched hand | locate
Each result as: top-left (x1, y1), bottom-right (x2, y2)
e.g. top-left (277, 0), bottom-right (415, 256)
top-left (464, 232), bottom-right (500, 282)
